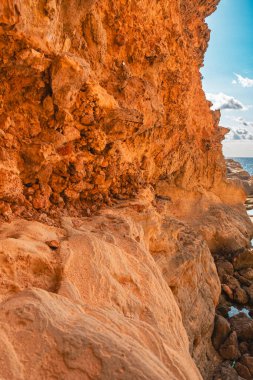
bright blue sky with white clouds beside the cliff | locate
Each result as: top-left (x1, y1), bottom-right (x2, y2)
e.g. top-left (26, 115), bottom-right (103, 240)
top-left (201, 0), bottom-right (253, 157)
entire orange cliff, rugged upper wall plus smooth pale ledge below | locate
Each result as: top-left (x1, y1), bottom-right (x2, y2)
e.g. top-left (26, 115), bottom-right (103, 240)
top-left (0, 0), bottom-right (253, 380)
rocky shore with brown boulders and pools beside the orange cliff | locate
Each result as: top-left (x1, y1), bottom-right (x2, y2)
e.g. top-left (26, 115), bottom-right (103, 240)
top-left (212, 159), bottom-right (253, 380)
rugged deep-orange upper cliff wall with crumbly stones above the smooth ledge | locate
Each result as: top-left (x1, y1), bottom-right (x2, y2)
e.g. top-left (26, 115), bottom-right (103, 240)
top-left (0, 0), bottom-right (231, 215)
